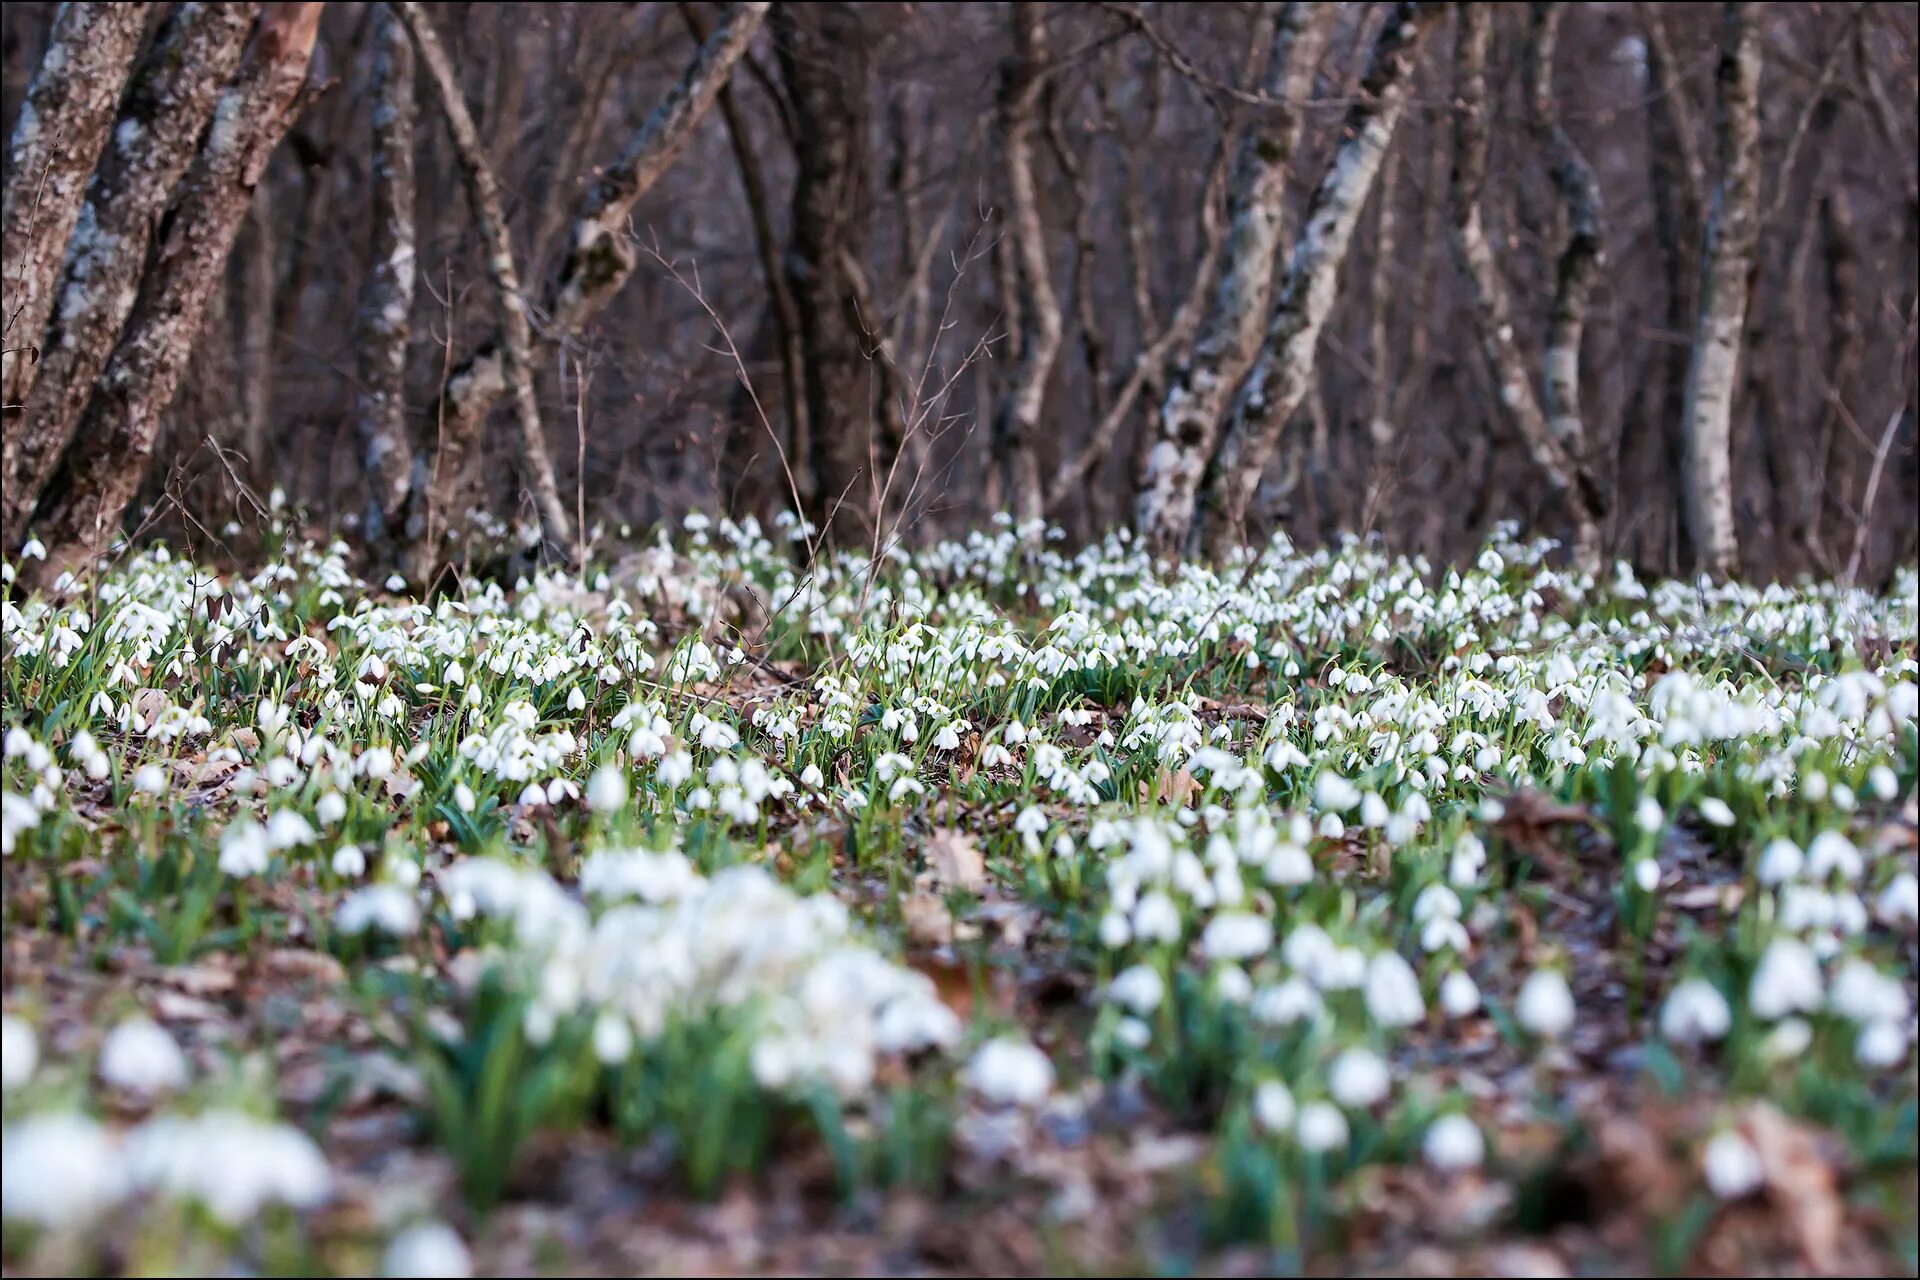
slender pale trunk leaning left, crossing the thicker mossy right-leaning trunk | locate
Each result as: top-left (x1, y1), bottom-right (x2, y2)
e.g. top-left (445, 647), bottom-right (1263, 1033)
top-left (394, 0), bottom-right (582, 580)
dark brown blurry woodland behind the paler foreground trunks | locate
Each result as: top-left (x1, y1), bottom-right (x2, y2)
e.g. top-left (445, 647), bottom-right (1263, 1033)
top-left (0, 2), bottom-right (1920, 581)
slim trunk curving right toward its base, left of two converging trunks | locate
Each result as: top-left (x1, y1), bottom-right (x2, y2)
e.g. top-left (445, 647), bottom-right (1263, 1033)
top-left (1452, 4), bottom-right (1601, 568)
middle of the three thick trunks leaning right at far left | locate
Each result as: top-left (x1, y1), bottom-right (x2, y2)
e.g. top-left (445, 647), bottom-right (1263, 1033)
top-left (0, 4), bottom-right (259, 539)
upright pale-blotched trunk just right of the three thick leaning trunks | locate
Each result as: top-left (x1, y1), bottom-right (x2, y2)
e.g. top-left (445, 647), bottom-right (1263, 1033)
top-left (353, 8), bottom-right (417, 558)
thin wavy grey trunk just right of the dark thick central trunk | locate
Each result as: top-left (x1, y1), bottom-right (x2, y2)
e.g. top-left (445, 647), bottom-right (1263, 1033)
top-left (995, 0), bottom-right (1064, 524)
